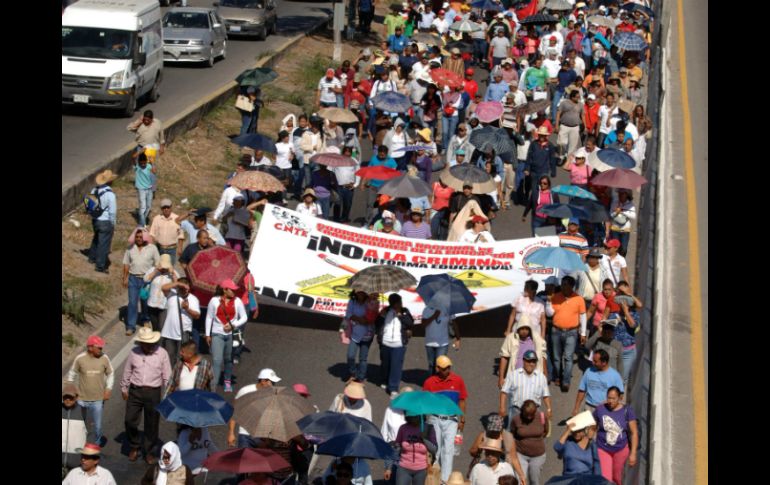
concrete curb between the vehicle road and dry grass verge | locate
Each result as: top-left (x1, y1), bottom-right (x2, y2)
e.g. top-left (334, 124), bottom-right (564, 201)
top-left (61, 17), bottom-right (329, 218)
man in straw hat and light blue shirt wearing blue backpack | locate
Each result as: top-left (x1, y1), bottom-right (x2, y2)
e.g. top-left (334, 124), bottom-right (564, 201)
top-left (80, 170), bottom-right (118, 273)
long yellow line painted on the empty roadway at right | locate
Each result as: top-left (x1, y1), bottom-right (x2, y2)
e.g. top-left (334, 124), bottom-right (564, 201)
top-left (677, 0), bottom-right (708, 485)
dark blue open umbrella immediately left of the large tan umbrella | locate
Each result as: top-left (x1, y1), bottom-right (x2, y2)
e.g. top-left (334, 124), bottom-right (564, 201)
top-left (155, 389), bottom-right (233, 428)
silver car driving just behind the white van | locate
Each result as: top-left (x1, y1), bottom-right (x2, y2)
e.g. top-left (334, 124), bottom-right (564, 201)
top-left (163, 7), bottom-right (227, 67)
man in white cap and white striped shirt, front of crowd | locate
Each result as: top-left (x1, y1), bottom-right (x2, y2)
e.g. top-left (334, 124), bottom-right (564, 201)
top-left (499, 350), bottom-right (552, 420)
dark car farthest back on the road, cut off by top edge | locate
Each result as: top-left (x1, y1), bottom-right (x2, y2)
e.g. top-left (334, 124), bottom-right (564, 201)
top-left (214, 0), bottom-right (278, 40)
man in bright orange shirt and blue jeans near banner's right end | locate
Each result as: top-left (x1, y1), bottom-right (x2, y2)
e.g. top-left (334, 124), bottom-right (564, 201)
top-left (545, 276), bottom-right (586, 392)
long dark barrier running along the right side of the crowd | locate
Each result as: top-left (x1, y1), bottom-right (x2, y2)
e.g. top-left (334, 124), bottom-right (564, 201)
top-left (623, 2), bottom-right (663, 485)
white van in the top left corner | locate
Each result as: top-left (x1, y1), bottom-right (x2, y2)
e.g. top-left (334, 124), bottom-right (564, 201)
top-left (61, 0), bottom-right (163, 116)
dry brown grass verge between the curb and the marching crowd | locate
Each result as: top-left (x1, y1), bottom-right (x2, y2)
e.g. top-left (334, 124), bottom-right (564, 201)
top-left (62, 26), bottom-right (384, 362)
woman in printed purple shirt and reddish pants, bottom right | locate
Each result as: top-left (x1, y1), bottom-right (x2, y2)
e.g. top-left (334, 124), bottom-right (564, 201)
top-left (594, 386), bottom-right (639, 484)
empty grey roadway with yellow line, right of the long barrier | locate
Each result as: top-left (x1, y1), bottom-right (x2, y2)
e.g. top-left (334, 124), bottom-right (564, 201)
top-left (659, 0), bottom-right (708, 483)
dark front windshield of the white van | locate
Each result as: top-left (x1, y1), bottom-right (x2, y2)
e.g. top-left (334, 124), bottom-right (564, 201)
top-left (61, 26), bottom-right (136, 59)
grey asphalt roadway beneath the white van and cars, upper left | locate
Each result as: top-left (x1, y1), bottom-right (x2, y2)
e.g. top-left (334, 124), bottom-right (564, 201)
top-left (62, 0), bottom-right (331, 193)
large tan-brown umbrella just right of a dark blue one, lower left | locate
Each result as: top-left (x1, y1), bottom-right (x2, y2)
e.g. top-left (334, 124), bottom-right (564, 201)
top-left (233, 387), bottom-right (314, 441)
